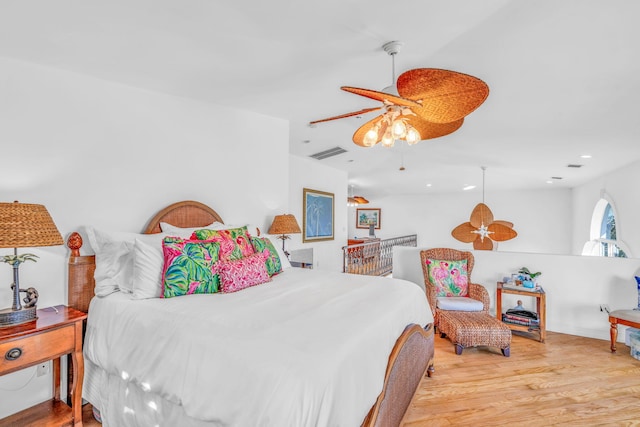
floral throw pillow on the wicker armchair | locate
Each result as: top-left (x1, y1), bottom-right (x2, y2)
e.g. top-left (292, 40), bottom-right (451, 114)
top-left (426, 259), bottom-right (469, 297)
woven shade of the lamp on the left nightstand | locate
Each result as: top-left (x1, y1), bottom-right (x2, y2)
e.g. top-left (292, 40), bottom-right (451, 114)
top-left (0, 202), bottom-right (64, 248)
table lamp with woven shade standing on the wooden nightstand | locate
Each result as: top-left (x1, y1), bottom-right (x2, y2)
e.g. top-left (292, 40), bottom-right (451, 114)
top-left (0, 201), bottom-right (64, 327)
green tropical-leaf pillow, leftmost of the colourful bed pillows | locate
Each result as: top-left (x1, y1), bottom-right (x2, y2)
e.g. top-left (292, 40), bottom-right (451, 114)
top-left (162, 237), bottom-right (220, 298)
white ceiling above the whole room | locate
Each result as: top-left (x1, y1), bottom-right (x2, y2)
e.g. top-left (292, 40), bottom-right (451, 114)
top-left (0, 0), bottom-right (640, 197)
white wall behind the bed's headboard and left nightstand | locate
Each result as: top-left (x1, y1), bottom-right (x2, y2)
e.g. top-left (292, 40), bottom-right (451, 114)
top-left (0, 58), bottom-right (288, 418)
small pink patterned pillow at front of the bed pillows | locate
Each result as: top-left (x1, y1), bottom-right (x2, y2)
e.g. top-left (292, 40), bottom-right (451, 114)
top-left (216, 252), bottom-right (271, 293)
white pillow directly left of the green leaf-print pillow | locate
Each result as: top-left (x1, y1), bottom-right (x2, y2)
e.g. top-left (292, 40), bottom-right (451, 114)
top-left (131, 239), bottom-right (164, 299)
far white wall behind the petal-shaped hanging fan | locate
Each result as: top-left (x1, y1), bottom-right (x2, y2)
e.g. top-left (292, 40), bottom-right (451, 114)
top-left (349, 189), bottom-right (572, 254)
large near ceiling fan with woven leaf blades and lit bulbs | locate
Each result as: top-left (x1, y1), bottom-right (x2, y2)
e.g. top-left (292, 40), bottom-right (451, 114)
top-left (309, 41), bottom-right (489, 147)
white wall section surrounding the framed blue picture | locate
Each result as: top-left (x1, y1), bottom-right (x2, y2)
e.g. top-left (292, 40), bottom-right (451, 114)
top-left (286, 156), bottom-right (347, 271)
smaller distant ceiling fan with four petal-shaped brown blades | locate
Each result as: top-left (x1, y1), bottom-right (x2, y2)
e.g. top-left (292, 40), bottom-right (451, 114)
top-left (451, 166), bottom-right (518, 251)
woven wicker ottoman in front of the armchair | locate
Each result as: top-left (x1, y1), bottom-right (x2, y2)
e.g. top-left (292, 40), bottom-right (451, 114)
top-left (438, 311), bottom-right (511, 357)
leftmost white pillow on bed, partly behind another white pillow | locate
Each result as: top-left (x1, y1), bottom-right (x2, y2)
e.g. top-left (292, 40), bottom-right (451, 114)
top-left (86, 227), bottom-right (166, 296)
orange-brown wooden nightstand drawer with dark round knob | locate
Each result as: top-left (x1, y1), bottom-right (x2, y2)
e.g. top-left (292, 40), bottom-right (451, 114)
top-left (0, 325), bottom-right (75, 375)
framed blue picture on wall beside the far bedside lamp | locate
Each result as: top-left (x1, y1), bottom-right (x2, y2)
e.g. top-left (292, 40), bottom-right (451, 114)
top-left (302, 188), bottom-right (334, 242)
